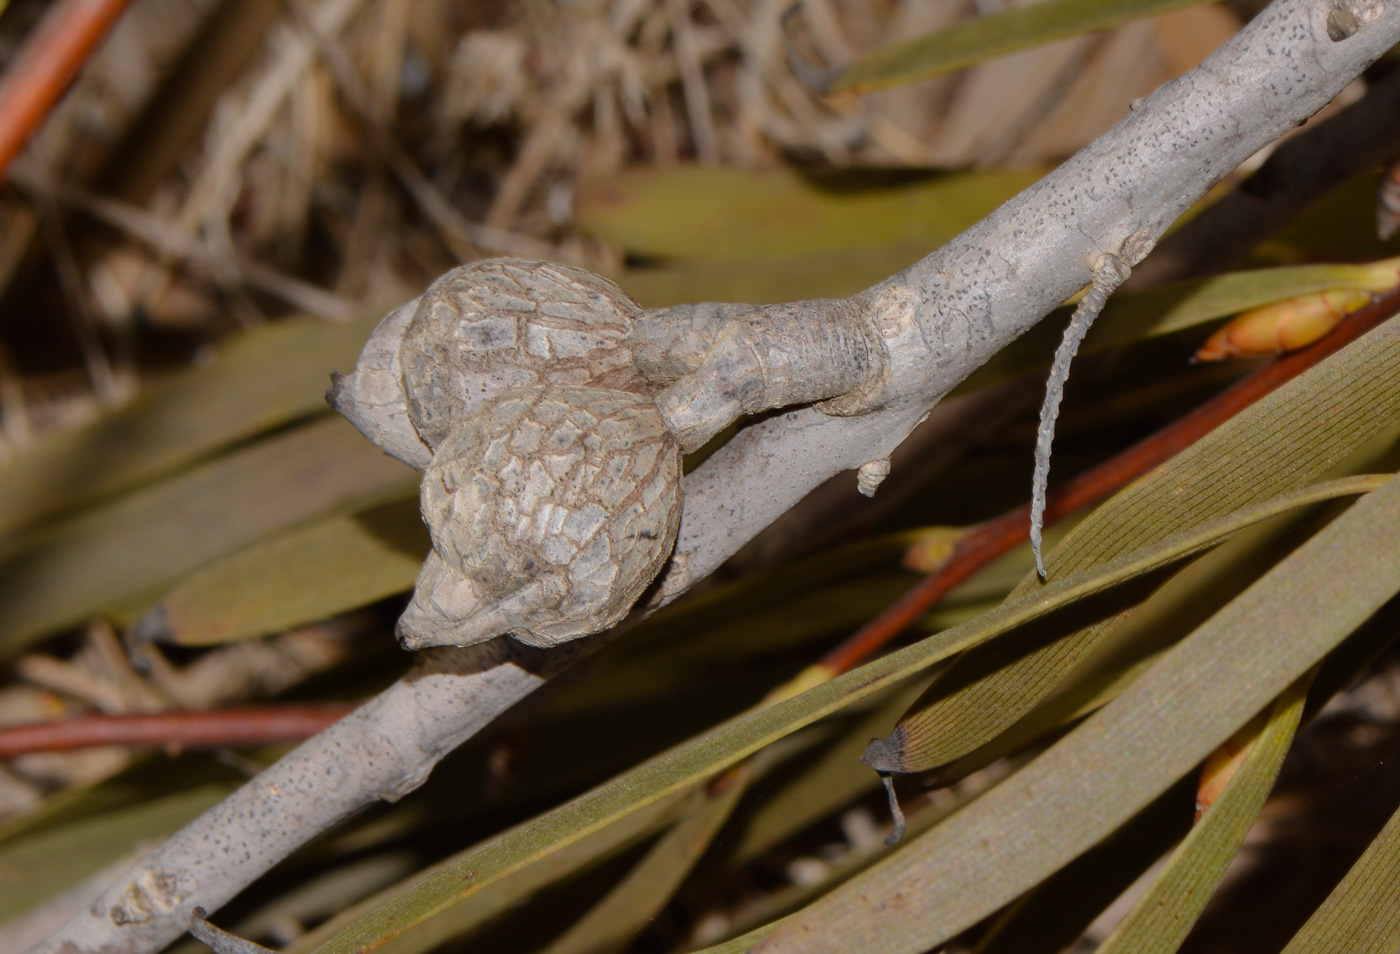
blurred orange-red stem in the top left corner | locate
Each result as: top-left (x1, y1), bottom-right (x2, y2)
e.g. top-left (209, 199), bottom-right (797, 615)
top-left (0, 0), bottom-right (130, 178)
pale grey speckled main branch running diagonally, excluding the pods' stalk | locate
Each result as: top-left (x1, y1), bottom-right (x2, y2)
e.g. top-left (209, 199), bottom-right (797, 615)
top-left (34, 0), bottom-right (1400, 954)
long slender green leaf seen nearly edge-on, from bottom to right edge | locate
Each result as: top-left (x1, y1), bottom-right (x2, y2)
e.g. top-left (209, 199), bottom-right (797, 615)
top-left (298, 476), bottom-right (1389, 954)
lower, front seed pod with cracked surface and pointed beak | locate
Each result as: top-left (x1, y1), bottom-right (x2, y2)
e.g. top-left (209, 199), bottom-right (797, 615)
top-left (400, 387), bottom-right (680, 647)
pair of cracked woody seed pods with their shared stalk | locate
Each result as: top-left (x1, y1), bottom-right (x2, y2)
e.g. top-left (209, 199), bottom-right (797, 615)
top-left (330, 259), bottom-right (888, 649)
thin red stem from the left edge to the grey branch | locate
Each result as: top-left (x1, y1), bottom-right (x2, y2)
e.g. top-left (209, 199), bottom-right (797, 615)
top-left (0, 694), bottom-right (354, 759)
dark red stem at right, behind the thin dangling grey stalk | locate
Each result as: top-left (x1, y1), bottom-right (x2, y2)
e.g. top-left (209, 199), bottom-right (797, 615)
top-left (819, 290), bottom-right (1400, 675)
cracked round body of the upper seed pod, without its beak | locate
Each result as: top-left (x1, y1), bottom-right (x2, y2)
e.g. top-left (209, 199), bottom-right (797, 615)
top-left (399, 259), bottom-right (648, 447)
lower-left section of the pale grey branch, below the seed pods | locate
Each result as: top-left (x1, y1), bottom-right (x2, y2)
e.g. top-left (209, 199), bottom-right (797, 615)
top-left (32, 646), bottom-right (562, 954)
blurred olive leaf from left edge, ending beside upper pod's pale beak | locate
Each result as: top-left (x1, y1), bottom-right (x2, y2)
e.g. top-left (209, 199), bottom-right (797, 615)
top-left (0, 310), bottom-right (378, 537)
